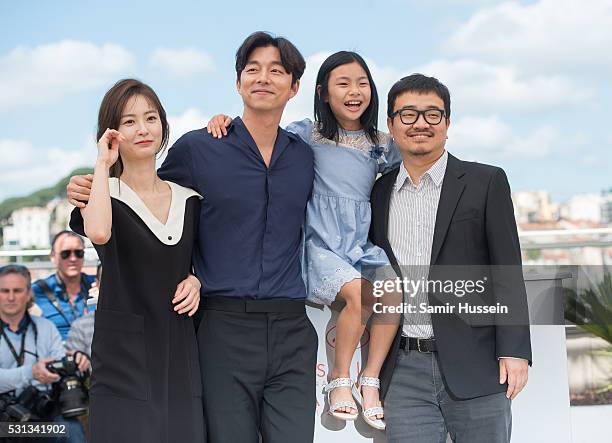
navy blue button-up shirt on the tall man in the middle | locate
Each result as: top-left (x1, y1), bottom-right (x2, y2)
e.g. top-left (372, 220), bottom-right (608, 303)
top-left (158, 118), bottom-right (314, 299)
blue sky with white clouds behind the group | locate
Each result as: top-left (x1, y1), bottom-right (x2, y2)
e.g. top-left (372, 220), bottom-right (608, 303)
top-left (0, 0), bottom-right (612, 202)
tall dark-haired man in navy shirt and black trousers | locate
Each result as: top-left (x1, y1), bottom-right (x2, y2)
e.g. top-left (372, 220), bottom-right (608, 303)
top-left (67, 32), bottom-right (317, 443)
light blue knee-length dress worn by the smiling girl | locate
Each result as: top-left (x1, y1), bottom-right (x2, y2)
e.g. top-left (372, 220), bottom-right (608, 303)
top-left (287, 119), bottom-right (400, 305)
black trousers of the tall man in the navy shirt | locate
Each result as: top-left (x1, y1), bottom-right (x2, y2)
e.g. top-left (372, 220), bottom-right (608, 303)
top-left (198, 300), bottom-right (318, 443)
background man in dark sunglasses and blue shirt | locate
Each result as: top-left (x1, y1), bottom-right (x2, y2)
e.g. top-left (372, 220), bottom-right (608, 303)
top-left (32, 231), bottom-right (95, 340)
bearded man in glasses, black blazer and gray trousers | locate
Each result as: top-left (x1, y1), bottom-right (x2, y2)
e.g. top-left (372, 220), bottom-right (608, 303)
top-left (370, 74), bottom-right (531, 443)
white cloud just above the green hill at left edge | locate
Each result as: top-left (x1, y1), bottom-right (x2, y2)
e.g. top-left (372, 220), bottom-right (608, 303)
top-left (0, 139), bottom-right (90, 200)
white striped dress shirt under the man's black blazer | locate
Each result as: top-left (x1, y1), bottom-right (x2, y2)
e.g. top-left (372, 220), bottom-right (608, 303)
top-left (388, 151), bottom-right (448, 338)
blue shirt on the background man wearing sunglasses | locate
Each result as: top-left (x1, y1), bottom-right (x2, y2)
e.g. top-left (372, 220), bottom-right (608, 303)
top-left (32, 273), bottom-right (96, 340)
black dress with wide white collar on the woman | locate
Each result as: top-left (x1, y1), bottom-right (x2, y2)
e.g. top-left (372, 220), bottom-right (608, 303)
top-left (70, 178), bottom-right (205, 443)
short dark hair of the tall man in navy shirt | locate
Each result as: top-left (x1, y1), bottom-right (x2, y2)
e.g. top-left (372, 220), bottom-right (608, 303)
top-left (236, 31), bottom-right (306, 85)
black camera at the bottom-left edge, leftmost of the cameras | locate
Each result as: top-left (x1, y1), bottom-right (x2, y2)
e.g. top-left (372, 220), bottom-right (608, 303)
top-left (0, 386), bottom-right (55, 422)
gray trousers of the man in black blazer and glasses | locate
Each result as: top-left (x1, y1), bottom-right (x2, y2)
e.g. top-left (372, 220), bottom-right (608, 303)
top-left (384, 349), bottom-right (512, 443)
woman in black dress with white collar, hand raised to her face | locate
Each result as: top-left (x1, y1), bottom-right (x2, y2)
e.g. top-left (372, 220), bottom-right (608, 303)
top-left (70, 79), bottom-right (205, 443)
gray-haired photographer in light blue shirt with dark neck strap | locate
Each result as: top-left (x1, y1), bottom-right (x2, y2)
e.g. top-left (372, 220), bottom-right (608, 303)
top-left (0, 265), bottom-right (86, 443)
